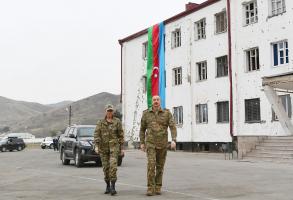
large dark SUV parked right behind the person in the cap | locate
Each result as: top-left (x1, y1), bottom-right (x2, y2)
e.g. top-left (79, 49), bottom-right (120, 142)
top-left (60, 125), bottom-right (123, 167)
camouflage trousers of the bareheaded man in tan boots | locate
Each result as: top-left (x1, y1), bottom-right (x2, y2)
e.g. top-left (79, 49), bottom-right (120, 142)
top-left (147, 148), bottom-right (167, 189)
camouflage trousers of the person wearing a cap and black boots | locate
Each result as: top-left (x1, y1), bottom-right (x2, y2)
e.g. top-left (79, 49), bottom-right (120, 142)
top-left (100, 149), bottom-right (118, 181)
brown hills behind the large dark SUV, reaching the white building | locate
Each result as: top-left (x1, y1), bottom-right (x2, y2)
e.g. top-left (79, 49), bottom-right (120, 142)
top-left (10, 92), bottom-right (121, 137)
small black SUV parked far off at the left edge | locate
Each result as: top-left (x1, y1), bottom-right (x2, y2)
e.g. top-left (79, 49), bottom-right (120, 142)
top-left (0, 137), bottom-right (25, 152)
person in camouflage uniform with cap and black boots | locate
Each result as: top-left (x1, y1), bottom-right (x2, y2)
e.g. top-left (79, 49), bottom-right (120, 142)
top-left (94, 104), bottom-right (124, 195)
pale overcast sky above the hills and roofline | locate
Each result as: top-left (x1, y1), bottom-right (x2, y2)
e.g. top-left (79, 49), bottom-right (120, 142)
top-left (0, 0), bottom-right (204, 104)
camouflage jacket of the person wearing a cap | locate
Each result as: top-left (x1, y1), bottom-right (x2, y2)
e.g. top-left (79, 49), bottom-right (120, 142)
top-left (94, 117), bottom-right (124, 151)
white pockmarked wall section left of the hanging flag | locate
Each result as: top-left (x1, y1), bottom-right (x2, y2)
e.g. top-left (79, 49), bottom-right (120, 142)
top-left (122, 35), bottom-right (147, 141)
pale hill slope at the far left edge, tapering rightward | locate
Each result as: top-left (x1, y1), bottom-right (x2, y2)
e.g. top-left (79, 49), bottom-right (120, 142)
top-left (0, 97), bottom-right (52, 127)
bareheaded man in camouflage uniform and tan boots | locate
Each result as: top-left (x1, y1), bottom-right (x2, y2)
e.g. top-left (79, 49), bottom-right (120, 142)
top-left (139, 96), bottom-right (177, 196)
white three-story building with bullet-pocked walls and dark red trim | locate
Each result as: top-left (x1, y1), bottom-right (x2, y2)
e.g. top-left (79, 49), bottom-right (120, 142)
top-left (119, 0), bottom-right (293, 154)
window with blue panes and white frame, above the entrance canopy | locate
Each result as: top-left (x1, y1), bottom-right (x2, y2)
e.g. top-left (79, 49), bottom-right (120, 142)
top-left (272, 41), bottom-right (289, 66)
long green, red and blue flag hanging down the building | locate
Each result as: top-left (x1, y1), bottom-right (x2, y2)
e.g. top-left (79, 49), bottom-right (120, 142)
top-left (147, 22), bottom-right (166, 109)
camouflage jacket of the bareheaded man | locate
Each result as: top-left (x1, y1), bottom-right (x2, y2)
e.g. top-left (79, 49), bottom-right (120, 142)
top-left (139, 108), bottom-right (177, 149)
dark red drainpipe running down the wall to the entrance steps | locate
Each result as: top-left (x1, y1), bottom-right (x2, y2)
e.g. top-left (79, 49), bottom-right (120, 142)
top-left (227, 0), bottom-right (234, 139)
